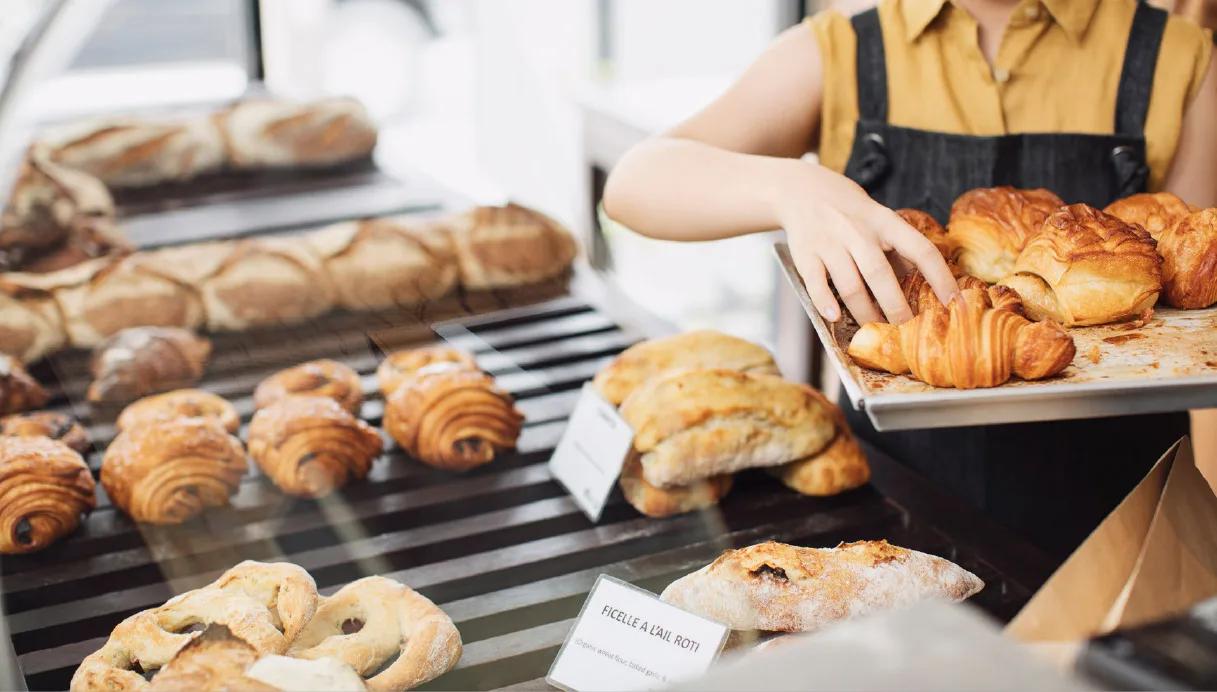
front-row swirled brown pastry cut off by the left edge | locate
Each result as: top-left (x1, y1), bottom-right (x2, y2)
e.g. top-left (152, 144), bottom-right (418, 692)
top-left (0, 437), bottom-right (97, 555)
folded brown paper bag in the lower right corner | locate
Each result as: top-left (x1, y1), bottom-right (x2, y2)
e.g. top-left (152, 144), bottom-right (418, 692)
top-left (1006, 438), bottom-right (1217, 641)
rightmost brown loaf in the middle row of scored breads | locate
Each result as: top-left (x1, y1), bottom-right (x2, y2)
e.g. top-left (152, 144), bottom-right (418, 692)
top-left (453, 204), bottom-right (578, 289)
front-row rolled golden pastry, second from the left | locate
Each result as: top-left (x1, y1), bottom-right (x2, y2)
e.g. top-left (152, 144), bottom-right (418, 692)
top-left (101, 418), bottom-right (247, 524)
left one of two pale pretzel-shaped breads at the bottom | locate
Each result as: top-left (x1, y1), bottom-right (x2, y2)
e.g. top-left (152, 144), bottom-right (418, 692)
top-left (71, 561), bottom-right (318, 692)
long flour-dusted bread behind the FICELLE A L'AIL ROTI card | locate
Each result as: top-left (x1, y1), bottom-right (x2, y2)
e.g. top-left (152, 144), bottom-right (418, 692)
top-left (661, 541), bottom-right (985, 632)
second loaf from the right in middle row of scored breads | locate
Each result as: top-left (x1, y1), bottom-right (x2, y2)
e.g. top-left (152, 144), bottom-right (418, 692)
top-left (305, 216), bottom-right (458, 310)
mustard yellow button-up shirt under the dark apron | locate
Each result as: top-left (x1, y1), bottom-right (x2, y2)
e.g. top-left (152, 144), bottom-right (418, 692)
top-left (808, 0), bottom-right (1212, 190)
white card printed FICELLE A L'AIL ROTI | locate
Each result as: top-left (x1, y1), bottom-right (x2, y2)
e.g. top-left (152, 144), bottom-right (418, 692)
top-left (545, 574), bottom-right (729, 692)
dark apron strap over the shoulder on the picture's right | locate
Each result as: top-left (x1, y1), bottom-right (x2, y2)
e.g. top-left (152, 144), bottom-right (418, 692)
top-left (1116, 0), bottom-right (1167, 137)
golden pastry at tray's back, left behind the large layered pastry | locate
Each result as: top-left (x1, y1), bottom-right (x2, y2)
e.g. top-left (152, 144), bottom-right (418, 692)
top-left (947, 187), bottom-right (1065, 283)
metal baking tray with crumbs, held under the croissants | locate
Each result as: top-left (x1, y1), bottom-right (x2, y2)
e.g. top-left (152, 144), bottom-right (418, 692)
top-left (774, 242), bottom-right (1217, 431)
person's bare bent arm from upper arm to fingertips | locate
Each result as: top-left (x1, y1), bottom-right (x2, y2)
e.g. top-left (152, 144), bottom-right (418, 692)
top-left (604, 24), bottom-right (958, 322)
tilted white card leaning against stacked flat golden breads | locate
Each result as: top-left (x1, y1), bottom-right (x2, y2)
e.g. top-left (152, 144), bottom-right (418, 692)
top-left (549, 382), bottom-right (634, 522)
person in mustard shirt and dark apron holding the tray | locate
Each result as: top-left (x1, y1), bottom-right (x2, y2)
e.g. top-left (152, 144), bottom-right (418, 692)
top-left (604, 0), bottom-right (1217, 557)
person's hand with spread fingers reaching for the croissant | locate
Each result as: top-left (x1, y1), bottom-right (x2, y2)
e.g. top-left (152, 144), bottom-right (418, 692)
top-left (773, 161), bottom-right (959, 325)
